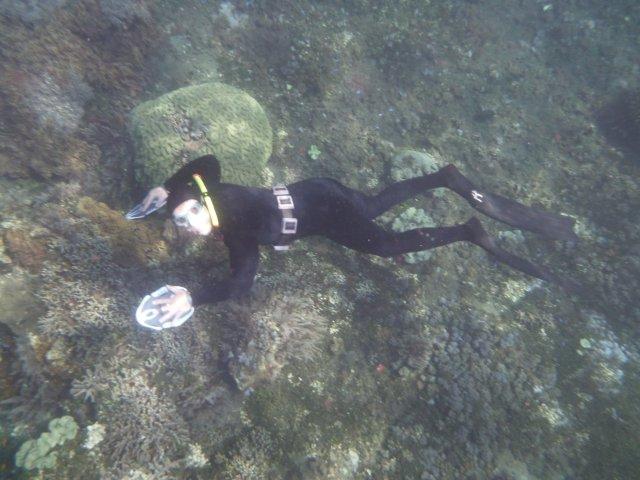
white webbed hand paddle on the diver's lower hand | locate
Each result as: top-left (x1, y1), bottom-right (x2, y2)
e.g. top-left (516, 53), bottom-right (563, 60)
top-left (136, 285), bottom-right (194, 330)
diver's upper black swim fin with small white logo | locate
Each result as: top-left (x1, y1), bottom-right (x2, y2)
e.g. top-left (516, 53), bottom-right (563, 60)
top-left (438, 165), bottom-right (577, 240)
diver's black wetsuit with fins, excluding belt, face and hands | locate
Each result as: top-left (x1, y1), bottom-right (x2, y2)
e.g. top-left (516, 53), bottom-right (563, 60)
top-left (165, 156), bottom-right (575, 306)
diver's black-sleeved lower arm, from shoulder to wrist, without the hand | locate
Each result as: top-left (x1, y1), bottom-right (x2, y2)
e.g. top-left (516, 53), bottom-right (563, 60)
top-left (191, 237), bottom-right (260, 307)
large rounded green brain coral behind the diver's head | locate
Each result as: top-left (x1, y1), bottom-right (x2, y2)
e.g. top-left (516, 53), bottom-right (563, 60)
top-left (130, 83), bottom-right (272, 187)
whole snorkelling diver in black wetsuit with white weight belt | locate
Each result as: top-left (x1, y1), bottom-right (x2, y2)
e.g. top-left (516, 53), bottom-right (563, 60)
top-left (126, 155), bottom-right (577, 330)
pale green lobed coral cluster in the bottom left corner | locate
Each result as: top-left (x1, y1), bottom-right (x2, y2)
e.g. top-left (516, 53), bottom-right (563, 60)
top-left (16, 415), bottom-right (78, 470)
